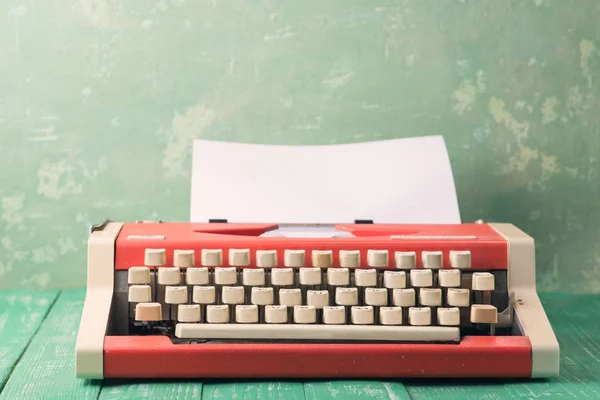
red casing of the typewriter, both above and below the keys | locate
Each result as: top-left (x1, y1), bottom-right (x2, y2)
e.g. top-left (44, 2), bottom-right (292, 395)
top-left (104, 223), bottom-right (532, 378)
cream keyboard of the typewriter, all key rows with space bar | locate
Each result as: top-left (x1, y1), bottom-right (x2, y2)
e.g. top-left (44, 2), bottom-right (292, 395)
top-left (113, 249), bottom-right (509, 342)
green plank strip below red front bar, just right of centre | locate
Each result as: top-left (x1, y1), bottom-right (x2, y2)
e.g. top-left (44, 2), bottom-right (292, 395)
top-left (304, 380), bottom-right (410, 400)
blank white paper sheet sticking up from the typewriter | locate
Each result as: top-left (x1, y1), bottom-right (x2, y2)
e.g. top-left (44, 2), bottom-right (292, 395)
top-left (190, 136), bottom-right (460, 224)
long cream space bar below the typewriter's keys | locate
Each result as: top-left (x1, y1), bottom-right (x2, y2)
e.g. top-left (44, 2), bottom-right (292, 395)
top-left (175, 323), bottom-right (460, 342)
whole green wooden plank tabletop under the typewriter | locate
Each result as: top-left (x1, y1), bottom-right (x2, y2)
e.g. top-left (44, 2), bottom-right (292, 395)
top-left (0, 289), bottom-right (600, 400)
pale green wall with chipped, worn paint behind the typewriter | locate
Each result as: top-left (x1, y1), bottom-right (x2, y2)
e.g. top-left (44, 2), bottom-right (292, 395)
top-left (0, 0), bottom-right (600, 292)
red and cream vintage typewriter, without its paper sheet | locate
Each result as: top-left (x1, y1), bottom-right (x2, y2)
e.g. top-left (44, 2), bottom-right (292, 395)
top-left (76, 221), bottom-right (559, 379)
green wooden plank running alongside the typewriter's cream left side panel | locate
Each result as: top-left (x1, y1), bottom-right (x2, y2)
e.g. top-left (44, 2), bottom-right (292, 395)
top-left (0, 289), bottom-right (101, 400)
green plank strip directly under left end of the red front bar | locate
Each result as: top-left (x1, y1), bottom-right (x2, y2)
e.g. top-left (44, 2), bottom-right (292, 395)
top-left (99, 379), bottom-right (202, 400)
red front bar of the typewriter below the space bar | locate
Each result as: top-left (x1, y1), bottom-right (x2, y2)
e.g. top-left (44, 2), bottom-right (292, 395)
top-left (103, 336), bottom-right (532, 378)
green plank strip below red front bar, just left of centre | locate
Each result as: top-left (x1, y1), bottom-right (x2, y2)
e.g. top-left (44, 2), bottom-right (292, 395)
top-left (202, 381), bottom-right (304, 400)
